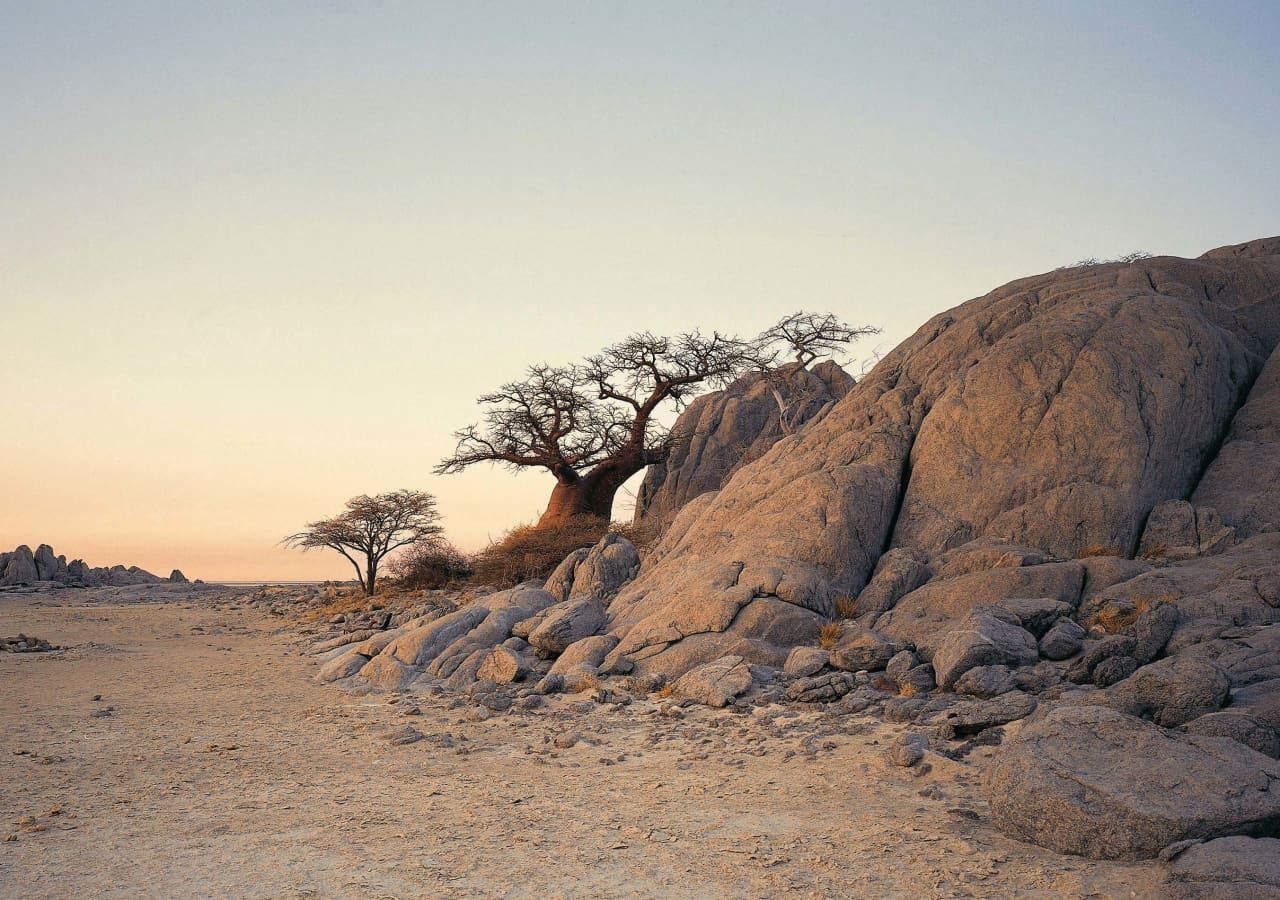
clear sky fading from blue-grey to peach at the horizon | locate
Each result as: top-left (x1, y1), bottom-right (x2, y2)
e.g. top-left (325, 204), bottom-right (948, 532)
top-left (0, 0), bottom-right (1280, 580)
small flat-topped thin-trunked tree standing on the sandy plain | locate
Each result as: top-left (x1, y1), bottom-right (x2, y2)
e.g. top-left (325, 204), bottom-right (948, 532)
top-left (282, 490), bottom-right (444, 595)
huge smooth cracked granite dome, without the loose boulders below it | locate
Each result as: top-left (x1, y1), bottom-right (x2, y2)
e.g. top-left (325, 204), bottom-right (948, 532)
top-left (609, 238), bottom-right (1280, 670)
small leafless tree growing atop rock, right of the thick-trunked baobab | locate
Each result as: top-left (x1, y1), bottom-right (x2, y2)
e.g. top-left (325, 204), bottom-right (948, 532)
top-left (755, 310), bottom-right (879, 434)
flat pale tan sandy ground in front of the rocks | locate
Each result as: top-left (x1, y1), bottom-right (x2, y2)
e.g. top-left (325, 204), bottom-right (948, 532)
top-left (0, 591), bottom-right (1162, 897)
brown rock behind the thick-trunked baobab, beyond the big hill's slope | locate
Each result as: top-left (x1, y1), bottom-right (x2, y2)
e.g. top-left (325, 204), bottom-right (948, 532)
top-left (635, 360), bottom-right (854, 526)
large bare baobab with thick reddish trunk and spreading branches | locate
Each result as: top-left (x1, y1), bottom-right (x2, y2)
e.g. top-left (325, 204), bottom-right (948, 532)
top-left (435, 332), bottom-right (759, 526)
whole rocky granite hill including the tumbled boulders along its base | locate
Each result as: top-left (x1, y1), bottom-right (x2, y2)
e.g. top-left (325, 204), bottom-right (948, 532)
top-left (304, 238), bottom-right (1280, 865)
